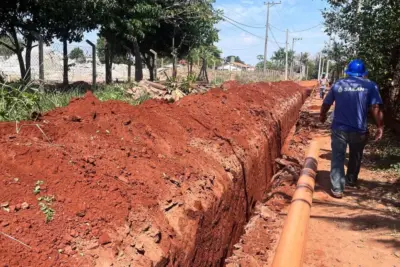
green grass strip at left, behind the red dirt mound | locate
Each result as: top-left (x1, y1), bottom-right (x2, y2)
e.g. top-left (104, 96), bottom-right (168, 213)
top-left (0, 83), bottom-right (151, 121)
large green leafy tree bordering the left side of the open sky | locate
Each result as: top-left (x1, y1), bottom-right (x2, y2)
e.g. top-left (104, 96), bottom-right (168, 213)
top-left (100, 0), bottom-right (218, 82)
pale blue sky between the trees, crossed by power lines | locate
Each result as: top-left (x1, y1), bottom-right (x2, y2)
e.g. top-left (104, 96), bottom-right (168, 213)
top-left (215, 0), bottom-right (328, 65)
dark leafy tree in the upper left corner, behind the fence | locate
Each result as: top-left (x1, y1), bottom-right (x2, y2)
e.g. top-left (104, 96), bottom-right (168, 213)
top-left (0, 0), bottom-right (98, 82)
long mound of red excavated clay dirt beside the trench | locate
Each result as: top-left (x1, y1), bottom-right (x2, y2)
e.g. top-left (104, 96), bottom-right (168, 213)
top-left (0, 82), bottom-right (306, 266)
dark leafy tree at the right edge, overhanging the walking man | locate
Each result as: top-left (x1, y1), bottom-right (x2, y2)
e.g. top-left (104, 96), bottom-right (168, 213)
top-left (323, 0), bottom-right (400, 115)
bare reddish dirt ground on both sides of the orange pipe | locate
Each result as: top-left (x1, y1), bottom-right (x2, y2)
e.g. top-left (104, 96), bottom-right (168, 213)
top-left (227, 82), bottom-right (400, 267)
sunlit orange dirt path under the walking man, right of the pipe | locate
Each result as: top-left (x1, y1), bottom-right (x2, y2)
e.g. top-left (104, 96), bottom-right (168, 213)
top-left (304, 93), bottom-right (400, 267)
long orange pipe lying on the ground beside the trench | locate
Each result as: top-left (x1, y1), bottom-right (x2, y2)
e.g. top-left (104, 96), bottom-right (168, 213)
top-left (272, 141), bottom-right (319, 267)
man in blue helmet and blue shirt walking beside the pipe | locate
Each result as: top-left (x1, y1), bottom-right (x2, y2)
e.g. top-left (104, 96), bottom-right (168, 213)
top-left (320, 59), bottom-right (383, 198)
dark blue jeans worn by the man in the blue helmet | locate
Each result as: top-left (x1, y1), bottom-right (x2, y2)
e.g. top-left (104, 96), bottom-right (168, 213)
top-left (331, 130), bottom-right (368, 192)
